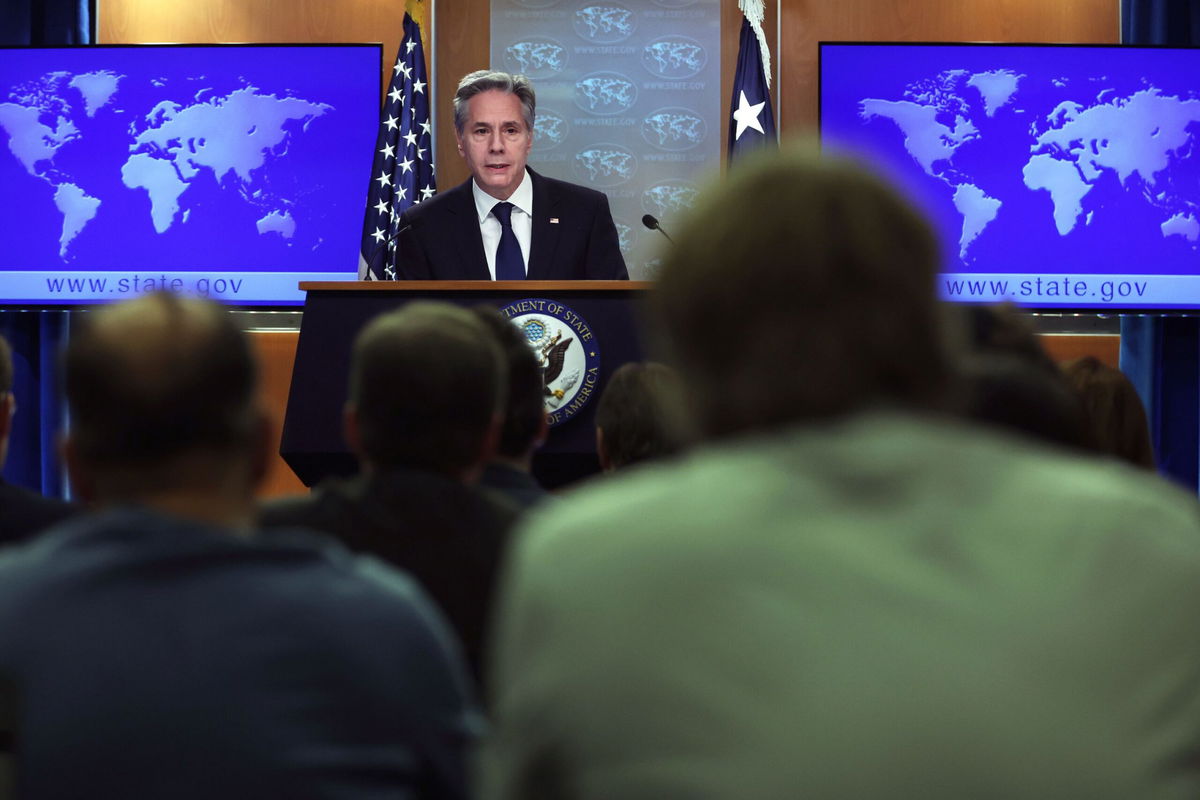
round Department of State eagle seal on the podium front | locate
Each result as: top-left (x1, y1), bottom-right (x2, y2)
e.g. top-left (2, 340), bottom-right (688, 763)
top-left (500, 297), bottom-right (600, 426)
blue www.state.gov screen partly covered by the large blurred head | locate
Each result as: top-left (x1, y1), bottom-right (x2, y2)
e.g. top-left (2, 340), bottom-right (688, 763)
top-left (821, 43), bottom-right (1200, 309)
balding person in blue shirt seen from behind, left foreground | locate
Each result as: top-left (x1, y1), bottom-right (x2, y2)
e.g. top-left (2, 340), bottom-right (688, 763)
top-left (0, 294), bottom-right (479, 799)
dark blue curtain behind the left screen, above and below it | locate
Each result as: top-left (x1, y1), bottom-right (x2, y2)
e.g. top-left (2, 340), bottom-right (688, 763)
top-left (0, 0), bottom-right (94, 497)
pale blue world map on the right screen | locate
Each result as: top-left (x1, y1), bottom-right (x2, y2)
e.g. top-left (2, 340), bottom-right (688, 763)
top-left (856, 68), bottom-right (1200, 266)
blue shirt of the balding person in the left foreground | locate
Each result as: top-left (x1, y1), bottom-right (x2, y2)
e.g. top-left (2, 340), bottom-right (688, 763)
top-left (0, 509), bottom-right (479, 800)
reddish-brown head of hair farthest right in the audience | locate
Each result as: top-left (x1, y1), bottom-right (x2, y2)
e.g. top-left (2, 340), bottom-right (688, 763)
top-left (1062, 356), bottom-right (1157, 470)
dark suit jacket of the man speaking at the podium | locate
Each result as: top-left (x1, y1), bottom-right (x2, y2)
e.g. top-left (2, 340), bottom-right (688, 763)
top-left (396, 169), bottom-right (629, 281)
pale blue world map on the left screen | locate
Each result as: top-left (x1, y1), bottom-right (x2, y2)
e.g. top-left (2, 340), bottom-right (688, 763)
top-left (0, 70), bottom-right (334, 264)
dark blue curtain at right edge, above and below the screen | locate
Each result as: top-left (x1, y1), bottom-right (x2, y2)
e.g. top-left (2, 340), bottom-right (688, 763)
top-left (1121, 0), bottom-right (1200, 492)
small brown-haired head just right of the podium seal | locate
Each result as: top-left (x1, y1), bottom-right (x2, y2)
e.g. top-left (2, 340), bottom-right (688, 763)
top-left (595, 361), bottom-right (684, 470)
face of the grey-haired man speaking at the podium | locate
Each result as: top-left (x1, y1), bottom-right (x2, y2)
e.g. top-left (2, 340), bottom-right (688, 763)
top-left (455, 89), bottom-right (533, 200)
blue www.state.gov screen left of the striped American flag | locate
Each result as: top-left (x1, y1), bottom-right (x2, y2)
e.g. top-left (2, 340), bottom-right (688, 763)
top-left (0, 44), bottom-right (380, 305)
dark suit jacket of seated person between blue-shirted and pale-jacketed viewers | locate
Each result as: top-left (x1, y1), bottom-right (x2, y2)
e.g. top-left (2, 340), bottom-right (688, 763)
top-left (259, 470), bottom-right (518, 695)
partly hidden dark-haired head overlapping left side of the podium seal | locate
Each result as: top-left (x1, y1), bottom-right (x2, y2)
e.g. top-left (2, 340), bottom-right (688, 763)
top-left (473, 306), bottom-right (546, 459)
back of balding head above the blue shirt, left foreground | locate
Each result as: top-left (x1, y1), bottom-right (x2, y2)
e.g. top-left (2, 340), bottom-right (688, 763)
top-left (64, 293), bottom-right (264, 501)
